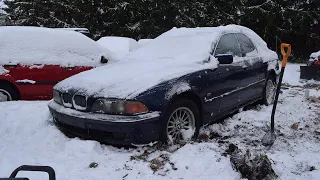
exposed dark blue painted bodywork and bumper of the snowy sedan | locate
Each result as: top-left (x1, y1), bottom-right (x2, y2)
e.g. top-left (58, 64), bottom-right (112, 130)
top-left (49, 29), bottom-right (278, 145)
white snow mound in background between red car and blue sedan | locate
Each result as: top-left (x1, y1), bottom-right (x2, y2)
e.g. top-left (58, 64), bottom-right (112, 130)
top-left (97, 36), bottom-right (139, 54)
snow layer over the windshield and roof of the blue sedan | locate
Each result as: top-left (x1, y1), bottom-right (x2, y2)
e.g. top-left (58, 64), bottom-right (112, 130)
top-left (129, 25), bottom-right (278, 61)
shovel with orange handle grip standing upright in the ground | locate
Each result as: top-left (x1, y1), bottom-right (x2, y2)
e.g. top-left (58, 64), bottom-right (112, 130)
top-left (262, 43), bottom-right (291, 146)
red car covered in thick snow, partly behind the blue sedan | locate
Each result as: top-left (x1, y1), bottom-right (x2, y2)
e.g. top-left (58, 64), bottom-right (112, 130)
top-left (0, 27), bottom-right (115, 102)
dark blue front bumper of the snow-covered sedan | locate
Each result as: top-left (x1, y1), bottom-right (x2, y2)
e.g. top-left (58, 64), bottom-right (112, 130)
top-left (48, 101), bottom-right (161, 145)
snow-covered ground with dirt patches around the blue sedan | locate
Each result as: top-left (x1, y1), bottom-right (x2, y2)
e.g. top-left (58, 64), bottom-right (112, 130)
top-left (0, 64), bottom-right (320, 180)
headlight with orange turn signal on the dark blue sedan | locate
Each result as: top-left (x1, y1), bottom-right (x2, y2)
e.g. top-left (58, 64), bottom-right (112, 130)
top-left (91, 99), bottom-right (148, 115)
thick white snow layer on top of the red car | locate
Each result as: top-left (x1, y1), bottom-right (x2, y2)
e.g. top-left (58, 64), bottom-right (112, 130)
top-left (0, 26), bottom-right (114, 66)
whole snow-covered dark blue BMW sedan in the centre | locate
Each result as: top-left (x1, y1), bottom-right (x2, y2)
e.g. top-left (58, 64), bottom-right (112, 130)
top-left (49, 25), bottom-right (279, 145)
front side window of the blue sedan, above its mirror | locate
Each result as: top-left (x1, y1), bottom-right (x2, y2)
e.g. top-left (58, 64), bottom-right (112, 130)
top-left (215, 34), bottom-right (241, 57)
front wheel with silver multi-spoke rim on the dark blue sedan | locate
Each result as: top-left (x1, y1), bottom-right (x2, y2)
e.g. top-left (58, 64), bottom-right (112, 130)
top-left (160, 99), bottom-right (200, 144)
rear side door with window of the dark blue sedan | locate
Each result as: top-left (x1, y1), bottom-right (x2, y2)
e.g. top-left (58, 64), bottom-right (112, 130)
top-left (236, 33), bottom-right (267, 101)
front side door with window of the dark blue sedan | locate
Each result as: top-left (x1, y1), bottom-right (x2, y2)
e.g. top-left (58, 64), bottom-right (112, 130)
top-left (205, 33), bottom-right (247, 119)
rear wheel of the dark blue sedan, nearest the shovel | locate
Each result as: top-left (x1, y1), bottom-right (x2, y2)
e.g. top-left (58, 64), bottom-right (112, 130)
top-left (261, 76), bottom-right (277, 106)
